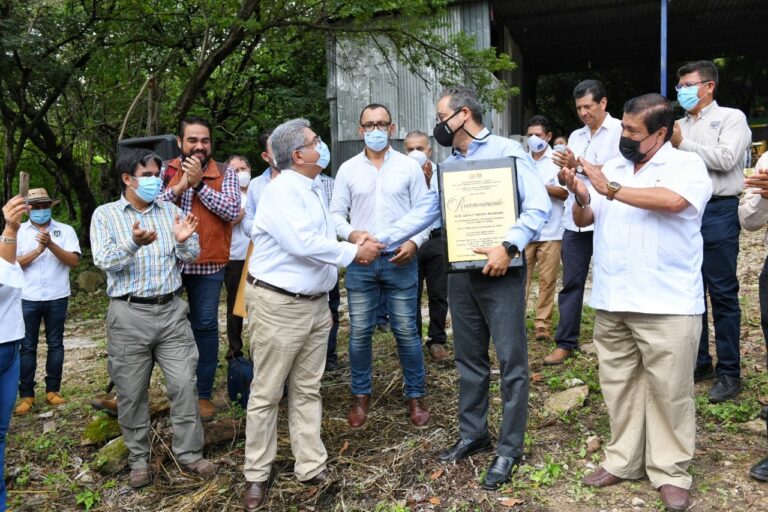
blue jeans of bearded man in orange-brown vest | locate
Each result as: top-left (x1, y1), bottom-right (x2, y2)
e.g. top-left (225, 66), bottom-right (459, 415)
top-left (181, 269), bottom-right (224, 400)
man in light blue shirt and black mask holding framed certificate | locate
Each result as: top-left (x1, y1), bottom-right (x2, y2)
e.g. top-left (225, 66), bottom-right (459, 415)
top-left (375, 87), bottom-right (550, 490)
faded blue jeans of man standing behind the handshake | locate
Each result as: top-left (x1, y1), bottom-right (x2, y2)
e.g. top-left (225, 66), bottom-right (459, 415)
top-left (346, 253), bottom-right (425, 398)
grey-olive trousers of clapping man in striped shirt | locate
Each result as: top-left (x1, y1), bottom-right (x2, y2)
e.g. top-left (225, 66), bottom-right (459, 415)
top-left (107, 297), bottom-right (203, 469)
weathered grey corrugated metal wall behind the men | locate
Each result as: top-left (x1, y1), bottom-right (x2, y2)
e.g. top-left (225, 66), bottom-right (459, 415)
top-left (327, 0), bottom-right (510, 174)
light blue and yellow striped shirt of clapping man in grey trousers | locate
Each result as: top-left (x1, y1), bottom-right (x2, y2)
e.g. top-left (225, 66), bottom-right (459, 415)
top-left (91, 196), bottom-right (200, 297)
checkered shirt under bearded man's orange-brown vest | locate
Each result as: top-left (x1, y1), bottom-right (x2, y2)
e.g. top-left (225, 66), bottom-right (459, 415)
top-left (160, 161), bottom-right (240, 274)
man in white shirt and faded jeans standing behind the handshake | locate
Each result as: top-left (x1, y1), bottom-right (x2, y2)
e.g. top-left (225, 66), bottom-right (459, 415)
top-left (331, 103), bottom-right (429, 428)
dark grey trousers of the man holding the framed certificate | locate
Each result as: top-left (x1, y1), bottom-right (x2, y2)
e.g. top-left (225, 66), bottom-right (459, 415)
top-left (448, 268), bottom-right (528, 457)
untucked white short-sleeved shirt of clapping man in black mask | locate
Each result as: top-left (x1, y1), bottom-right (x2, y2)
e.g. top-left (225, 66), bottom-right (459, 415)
top-left (590, 142), bottom-right (712, 315)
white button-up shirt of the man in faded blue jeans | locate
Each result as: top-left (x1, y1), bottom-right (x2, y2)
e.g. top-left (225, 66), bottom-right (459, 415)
top-left (331, 147), bottom-right (429, 251)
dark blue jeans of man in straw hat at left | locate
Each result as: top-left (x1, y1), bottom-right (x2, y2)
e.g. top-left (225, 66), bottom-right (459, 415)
top-left (19, 297), bottom-right (69, 398)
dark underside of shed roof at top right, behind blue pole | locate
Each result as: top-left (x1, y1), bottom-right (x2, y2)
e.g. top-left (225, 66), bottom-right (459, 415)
top-left (491, 0), bottom-right (768, 74)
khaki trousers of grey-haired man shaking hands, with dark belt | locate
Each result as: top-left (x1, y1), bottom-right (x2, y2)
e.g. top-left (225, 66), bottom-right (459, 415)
top-left (244, 285), bottom-right (331, 482)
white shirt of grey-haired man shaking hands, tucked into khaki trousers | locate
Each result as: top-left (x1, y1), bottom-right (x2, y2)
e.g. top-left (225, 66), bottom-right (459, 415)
top-left (248, 169), bottom-right (362, 295)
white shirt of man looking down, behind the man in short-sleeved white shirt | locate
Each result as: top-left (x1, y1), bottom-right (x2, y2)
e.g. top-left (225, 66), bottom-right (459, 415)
top-left (563, 112), bottom-right (622, 231)
